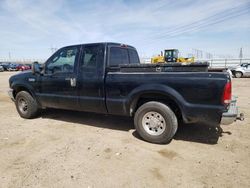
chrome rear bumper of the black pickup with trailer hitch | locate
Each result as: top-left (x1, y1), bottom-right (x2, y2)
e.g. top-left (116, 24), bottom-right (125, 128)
top-left (221, 97), bottom-right (244, 125)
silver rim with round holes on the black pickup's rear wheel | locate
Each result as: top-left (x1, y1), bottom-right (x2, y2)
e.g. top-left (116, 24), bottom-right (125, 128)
top-left (142, 111), bottom-right (166, 136)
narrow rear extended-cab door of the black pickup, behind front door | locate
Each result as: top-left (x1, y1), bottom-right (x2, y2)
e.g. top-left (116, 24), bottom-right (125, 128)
top-left (78, 44), bottom-right (107, 113)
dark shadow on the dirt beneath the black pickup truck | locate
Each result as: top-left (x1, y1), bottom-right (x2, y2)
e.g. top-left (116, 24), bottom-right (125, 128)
top-left (41, 109), bottom-right (231, 145)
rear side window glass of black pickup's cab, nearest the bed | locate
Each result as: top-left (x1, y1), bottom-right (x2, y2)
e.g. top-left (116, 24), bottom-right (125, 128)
top-left (109, 47), bottom-right (129, 66)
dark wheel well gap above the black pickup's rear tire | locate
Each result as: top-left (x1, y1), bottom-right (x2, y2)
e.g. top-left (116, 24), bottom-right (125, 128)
top-left (133, 93), bottom-right (183, 120)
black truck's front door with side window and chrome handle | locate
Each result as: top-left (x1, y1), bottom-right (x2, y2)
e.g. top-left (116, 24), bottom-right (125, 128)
top-left (38, 46), bottom-right (80, 109)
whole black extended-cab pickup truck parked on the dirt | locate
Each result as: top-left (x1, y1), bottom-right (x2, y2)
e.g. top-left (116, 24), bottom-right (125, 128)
top-left (9, 43), bottom-right (242, 143)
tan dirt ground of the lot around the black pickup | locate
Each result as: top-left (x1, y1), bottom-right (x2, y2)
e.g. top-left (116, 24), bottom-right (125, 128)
top-left (0, 72), bottom-right (250, 188)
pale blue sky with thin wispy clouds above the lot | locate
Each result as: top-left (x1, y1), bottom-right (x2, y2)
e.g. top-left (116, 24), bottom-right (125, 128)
top-left (0, 0), bottom-right (250, 59)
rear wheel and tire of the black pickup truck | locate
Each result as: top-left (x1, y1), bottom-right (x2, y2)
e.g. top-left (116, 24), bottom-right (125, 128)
top-left (134, 101), bottom-right (178, 144)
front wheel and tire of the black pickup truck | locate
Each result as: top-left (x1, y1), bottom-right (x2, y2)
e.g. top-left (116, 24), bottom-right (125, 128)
top-left (15, 91), bottom-right (40, 119)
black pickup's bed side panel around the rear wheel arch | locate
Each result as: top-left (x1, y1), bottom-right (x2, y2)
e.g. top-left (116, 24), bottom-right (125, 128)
top-left (106, 72), bottom-right (230, 126)
